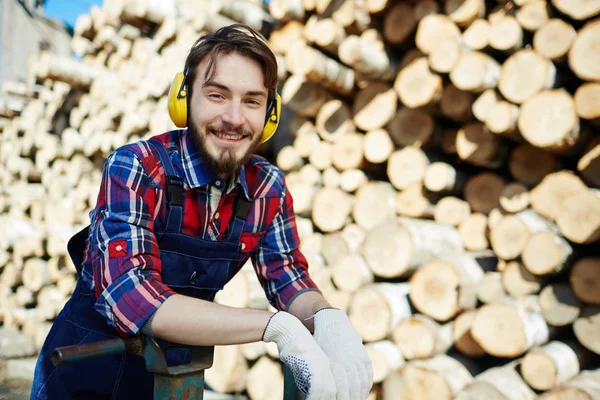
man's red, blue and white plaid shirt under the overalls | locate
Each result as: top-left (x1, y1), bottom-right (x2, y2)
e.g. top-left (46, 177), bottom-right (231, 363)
top-left (82, 131), bottom-right (324, 335)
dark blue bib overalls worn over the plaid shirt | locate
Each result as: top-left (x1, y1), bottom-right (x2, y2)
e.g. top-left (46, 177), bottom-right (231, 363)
top-left (31, 139), bottom-right (251, 400)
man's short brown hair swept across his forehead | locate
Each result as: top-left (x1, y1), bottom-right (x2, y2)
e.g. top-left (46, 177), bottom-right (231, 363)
top-left (185, 24), bottom-right (277, 103)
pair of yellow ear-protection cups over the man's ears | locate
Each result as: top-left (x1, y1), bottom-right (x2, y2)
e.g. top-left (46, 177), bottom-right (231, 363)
top-left (168, 72), bottom-right (281, 143)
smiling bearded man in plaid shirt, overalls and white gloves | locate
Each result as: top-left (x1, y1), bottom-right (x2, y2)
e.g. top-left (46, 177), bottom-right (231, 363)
top-left (31, 25), bottom-right (372, 400)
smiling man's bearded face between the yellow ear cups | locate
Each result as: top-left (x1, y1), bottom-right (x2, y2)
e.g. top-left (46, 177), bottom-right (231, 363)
top-left (188, 53), bottom-right (267, 178)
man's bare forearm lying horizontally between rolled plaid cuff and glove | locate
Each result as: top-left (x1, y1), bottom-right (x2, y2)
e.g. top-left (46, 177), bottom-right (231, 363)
top-left (151, 294), bottom-right (273, 346)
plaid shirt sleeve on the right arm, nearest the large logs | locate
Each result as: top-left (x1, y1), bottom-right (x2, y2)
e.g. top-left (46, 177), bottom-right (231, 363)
top-left (252, 186), bottom-right (318, 310)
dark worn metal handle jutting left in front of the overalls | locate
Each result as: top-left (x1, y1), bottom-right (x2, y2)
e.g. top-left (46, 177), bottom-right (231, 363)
top-left (50, 337), bottom-right (142, 367)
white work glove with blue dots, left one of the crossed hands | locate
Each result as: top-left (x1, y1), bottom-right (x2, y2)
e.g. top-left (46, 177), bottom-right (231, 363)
top-left (263, 311), bottom-right (335, 400)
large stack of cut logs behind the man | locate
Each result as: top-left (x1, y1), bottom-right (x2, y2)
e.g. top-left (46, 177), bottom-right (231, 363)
top-left (0, 0), bottom-right (600, 400)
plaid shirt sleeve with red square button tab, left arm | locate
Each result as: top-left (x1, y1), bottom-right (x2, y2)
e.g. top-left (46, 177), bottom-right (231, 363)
top-left (90, 149), bottom-right (174, 335)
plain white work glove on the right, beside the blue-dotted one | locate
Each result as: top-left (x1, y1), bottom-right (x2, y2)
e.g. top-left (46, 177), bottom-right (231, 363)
top-left (314, 308), bottom-right (373, 400)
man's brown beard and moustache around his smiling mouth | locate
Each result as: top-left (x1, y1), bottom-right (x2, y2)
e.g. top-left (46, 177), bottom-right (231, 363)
top-left (187, 115), bottom-right (262, 179)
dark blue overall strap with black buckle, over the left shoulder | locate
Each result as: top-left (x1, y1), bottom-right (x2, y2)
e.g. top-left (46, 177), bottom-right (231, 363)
top-left (148, 139), bottom-right (185, 232)
